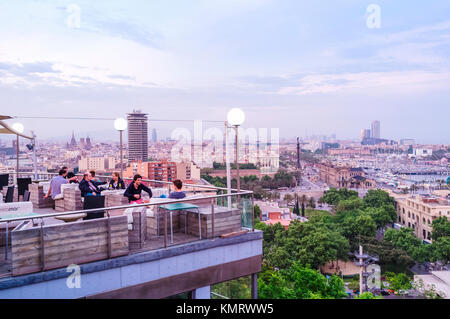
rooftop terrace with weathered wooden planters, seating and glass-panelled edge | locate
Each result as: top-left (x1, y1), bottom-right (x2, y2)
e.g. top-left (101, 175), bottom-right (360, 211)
top-left (0, 177), bottom-right (262, 297)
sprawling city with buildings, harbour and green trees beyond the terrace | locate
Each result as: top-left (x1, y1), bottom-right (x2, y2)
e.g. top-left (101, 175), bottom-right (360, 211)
top-left (0, 110), bottom-right (450, 299)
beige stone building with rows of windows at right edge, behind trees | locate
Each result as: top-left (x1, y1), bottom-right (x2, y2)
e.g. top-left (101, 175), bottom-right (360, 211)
top-left (395, 195), bottom-right (450, 243)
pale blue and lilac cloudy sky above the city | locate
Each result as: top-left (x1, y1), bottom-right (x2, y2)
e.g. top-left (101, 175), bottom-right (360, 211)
top-left (0, 0), bottom-right (450, 143)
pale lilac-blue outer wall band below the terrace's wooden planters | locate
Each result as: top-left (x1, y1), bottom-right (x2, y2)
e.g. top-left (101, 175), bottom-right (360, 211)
top-left (0, 231), bottom-right (262, 299)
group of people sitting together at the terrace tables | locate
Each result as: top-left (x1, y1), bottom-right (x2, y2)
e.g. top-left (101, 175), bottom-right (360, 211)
top-left (44, 167), bottom-right (186, 208)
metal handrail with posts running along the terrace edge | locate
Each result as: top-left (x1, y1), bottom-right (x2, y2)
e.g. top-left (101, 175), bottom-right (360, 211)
top-left (0, 190), bottom-right (254, 276)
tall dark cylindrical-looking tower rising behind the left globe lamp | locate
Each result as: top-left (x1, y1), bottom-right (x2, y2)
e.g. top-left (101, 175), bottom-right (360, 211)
top-left (127, 110), bottom-right (148, 162)
